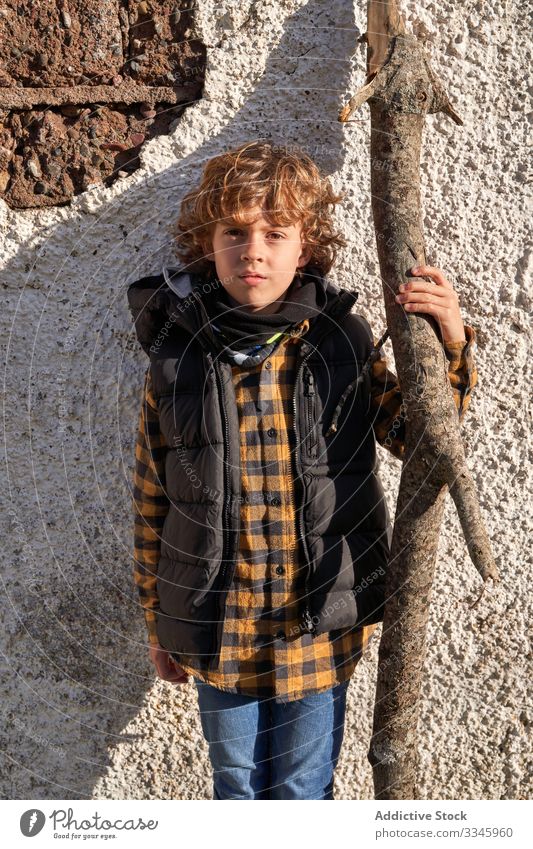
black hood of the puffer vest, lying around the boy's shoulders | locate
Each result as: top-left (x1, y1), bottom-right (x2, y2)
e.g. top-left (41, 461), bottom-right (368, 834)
top-left (127, 266), bottom-right (359, 356)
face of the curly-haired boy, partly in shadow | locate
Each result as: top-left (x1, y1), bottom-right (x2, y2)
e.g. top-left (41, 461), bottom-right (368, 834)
top-left (204, 207), bottom-right (312, 314)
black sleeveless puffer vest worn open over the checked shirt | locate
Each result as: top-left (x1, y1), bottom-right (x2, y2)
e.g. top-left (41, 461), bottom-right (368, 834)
top-left (128, 269), bottom-right (391, 669)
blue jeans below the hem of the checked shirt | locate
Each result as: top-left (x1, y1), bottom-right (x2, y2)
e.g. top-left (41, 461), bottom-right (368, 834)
top-left (194, 677), bottom-right (349, 799)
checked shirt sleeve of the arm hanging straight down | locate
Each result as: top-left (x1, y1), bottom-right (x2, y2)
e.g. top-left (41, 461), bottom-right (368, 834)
top-left (133, 369), bottom-right (169, 645)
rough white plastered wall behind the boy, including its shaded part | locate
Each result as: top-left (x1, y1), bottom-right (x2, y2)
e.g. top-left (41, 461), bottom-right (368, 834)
top-left (0, 0), bottom-right (532, 799)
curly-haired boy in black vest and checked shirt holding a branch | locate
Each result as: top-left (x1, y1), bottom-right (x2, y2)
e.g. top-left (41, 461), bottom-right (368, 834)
top-left (128, 142), bottom-right (477, 799)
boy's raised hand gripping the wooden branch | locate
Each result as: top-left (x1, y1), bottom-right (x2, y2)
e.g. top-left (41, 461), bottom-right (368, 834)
top-left (395, 265), bottom-right (466, 342)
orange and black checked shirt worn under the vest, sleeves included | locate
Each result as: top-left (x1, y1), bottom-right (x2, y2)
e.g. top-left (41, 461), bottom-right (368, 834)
top-left (133, 319), bottom-right (477, 701)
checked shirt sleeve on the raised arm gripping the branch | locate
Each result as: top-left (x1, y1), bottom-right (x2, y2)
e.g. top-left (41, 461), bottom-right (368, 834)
top-left (370, 325), bottom-right (478, 460)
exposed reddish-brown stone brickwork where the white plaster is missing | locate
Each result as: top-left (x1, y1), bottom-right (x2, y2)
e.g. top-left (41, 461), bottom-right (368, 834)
top-left (0, 0), bottom-right (205, 209)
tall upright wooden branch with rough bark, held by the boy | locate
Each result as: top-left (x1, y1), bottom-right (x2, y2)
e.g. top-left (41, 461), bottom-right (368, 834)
top-left (339, 0), bottom-right (499, 799)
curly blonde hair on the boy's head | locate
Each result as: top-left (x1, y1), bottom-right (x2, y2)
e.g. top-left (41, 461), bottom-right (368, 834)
top-left (171, 141), bottom-right (347, 274)
